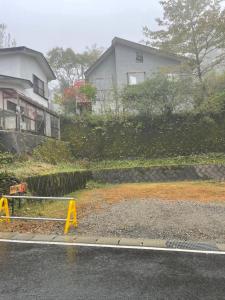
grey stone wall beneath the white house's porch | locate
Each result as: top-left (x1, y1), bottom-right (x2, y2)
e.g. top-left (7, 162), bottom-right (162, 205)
top-left (0, 130), bottom-right (47, 154)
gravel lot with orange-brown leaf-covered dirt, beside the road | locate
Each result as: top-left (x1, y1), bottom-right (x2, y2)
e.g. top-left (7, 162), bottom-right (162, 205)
top-left (0, 182), bottom-right (225, 242)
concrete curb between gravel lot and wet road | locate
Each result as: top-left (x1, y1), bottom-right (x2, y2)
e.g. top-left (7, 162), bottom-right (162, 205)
top-left (0, 232), bottom-right (225, 251)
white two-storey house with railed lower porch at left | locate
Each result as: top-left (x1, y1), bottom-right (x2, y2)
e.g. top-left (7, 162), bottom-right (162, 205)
top-left (0, 47), bottom-right (60, 142)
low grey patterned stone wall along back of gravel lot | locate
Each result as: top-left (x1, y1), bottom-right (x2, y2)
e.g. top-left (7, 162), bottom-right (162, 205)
top-left (92, 165), bottom-right (225, 183)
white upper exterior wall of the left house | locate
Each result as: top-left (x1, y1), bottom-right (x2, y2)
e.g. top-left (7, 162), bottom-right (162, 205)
top-left (0, 53), bottom-right (48, 107)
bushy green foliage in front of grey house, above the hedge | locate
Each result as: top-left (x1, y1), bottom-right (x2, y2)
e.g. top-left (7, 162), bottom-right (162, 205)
top-left (121, 74), bottom-right (192, 116)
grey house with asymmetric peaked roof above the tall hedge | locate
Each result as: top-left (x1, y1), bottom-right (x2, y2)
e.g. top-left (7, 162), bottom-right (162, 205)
top-left (85, 37), bottom-right (185, 113)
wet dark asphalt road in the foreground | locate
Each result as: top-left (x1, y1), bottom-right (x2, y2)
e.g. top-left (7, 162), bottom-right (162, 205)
top-left (0, 243), bottom-right (225, 300)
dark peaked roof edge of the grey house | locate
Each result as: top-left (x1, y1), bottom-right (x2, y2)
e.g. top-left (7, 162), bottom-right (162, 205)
top-left (85, 37), bottom-right (188, 75)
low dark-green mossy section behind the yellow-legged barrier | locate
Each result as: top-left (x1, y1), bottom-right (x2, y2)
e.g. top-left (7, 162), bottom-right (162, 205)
top-left (26, 171), bottom-right (91, 196)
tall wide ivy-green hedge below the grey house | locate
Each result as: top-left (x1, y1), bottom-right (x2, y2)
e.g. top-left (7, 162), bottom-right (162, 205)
top-left (61, 114), bottom-right (225, 160)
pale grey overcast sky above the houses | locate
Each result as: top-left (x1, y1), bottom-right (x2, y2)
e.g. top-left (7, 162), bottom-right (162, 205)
top-left (0, 0), bottom-right (162, 53)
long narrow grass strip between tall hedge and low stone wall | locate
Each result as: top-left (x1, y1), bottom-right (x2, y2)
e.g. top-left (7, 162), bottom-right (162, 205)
top-left (0, 153), bottom-right (225, 179)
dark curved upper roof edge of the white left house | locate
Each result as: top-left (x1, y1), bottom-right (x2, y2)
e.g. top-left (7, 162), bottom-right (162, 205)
top-left (0, 46), bottom-right (56, 80)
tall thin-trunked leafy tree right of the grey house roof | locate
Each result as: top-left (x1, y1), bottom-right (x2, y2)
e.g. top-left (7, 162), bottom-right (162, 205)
top-left (143, 0), bottom-right (225, 86)
